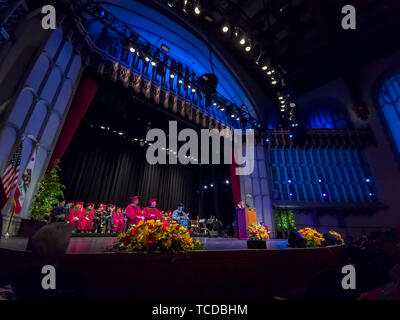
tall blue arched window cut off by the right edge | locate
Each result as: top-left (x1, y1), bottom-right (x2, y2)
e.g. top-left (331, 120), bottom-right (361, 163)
top-left (379, 74), bottom-right (400, 152)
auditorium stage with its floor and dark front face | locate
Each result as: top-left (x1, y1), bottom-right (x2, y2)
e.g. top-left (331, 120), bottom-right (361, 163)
top-left (0, 237), bottom-right (344, 301)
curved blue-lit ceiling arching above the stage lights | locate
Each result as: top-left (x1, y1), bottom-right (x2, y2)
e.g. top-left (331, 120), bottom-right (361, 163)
top-left (89, 0), bottom-right (257, 118)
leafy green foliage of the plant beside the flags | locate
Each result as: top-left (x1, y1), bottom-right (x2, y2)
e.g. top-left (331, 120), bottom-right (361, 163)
top-left (31, 160), bottom-right (65, 220)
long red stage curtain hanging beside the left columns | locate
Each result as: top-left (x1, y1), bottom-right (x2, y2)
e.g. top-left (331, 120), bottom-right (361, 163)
top-left (49, 78), bottom-right (99, 169)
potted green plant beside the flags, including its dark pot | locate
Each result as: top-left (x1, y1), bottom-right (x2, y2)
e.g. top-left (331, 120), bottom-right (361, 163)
top-left (19, 160), bottom-right (65, 237)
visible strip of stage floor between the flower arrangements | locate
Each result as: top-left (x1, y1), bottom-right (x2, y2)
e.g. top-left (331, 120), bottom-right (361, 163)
top-left (0, 237), bottom-right (292, 253)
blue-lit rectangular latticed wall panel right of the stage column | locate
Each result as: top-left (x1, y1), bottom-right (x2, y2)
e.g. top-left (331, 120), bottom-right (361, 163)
top-left (270, 148), bottom-right (375, 203)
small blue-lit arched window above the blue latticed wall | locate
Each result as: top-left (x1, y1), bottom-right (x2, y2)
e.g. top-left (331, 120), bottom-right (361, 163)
top-left (303, 99), bottom-right (349, 129)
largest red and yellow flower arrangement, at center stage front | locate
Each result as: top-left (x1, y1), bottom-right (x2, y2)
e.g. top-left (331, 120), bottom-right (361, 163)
top-left (113, 220), bottom-right (203, 252)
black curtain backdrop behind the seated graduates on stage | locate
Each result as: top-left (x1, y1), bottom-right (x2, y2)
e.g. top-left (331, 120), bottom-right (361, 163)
top-left (60, 77), bottom-right (234, 224)
